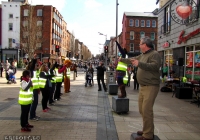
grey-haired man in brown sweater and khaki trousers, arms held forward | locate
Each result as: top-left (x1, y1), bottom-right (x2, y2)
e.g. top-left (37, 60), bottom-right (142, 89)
top-left (120, 37), bottom-right (161, 140)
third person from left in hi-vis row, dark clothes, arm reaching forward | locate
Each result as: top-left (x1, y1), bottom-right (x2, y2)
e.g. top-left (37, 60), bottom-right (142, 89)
top-left (39, 64), bottom-right (53, 112)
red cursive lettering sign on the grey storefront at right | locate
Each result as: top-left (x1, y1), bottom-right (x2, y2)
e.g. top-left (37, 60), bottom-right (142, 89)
top-left (177, 28), bottom-right (200, 44)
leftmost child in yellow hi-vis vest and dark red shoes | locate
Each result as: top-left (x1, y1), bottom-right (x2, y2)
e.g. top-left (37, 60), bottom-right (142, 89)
top-left (18, 70), bottom-right (33, 132)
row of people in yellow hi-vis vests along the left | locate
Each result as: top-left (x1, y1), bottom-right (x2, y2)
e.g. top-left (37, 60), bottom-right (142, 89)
top-left (18, 55), bottom-right (72, 132)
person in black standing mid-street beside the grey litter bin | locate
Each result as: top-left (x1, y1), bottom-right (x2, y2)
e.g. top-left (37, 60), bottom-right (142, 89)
top-left (96, 62), bottom-right (107, 92)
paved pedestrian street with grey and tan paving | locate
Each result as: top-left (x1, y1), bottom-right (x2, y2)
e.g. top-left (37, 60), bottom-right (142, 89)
top-left (0, 69), bottom-right (200, 140)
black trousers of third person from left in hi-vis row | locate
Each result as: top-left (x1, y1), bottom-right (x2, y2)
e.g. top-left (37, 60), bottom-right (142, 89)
top-left (40, 87), bottom-right (50, 110)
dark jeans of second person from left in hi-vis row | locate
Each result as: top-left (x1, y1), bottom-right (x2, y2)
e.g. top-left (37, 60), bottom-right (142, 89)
top-left (30, 89), bottom-right (39, 119)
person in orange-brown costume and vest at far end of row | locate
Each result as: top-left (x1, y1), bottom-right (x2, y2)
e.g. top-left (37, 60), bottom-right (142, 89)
top-left (64, 59), bottom-right (72, 93)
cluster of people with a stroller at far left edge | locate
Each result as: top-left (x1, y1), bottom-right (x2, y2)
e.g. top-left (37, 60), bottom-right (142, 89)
top-left (0, 60), bottom-right (17, 84)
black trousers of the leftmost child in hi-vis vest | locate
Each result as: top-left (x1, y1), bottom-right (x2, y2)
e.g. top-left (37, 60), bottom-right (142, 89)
top-left (20, 104), bottom-right (31, 127)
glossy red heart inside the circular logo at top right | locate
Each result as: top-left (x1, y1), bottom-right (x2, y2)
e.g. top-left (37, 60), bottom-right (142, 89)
top-left (176, 5), bottom-right (192, 19)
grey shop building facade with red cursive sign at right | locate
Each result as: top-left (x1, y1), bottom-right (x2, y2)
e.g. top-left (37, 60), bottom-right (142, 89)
top-left (157, 0), bottom-right (200, 81)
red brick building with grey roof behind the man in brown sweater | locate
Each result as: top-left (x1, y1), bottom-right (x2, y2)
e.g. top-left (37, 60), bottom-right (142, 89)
top-left (119, 12), bottom-right (157, 56)
